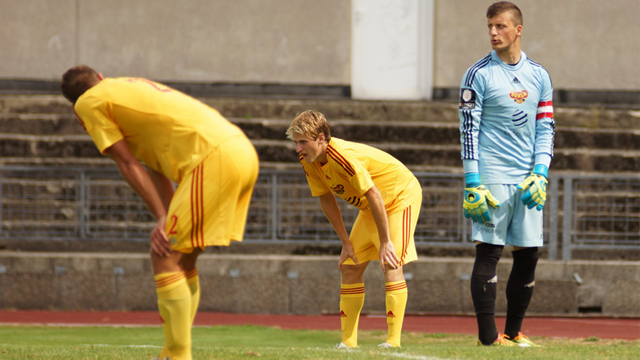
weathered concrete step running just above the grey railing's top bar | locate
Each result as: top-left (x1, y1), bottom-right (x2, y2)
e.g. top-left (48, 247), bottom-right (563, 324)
top-left (0, 134), bottom-right (640, 172)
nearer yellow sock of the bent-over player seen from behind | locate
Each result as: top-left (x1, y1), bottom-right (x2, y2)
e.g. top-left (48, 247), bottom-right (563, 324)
top-left (153, 272), bottom-right (192, 360)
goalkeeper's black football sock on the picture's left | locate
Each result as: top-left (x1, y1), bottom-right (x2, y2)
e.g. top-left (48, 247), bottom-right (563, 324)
top-left (471, 243), bottom-right (504, 345)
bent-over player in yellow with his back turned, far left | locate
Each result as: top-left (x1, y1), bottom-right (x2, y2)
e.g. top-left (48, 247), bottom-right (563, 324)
top-left (61, 65), bottom-right (259, 360)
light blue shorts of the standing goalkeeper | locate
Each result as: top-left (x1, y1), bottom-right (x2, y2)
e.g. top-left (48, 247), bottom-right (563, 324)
top-left (471, 184), bottom-right (543, 247)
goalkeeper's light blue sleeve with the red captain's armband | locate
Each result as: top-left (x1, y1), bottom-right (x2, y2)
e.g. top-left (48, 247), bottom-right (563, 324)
top-left (535, 70), bottom-right (556, 167)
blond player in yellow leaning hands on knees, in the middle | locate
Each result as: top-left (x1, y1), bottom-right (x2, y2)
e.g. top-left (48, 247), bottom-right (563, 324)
top-left (286, 110), bottom-right (422, 348)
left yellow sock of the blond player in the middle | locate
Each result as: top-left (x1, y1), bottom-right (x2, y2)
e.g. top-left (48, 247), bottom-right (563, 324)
top-left (340, 283), bottom-right (364, 347)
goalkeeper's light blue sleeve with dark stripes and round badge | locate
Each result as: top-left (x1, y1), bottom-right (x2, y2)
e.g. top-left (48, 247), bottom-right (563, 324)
top-left (458, 66), bottom-right (485, 160)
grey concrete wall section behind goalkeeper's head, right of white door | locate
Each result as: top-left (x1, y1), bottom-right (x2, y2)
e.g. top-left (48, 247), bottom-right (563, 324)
top-left (434, 0), bottom-right (640, 91)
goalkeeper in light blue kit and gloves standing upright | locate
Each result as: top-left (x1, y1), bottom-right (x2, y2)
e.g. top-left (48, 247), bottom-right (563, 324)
top-left (459, 1), bottom-right (555, 346)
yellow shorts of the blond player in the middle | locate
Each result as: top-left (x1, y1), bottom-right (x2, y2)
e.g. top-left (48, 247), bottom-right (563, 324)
top-left (344, 196), bottom-right (422, 265)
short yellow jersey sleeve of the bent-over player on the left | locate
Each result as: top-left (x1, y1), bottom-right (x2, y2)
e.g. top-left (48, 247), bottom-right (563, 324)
top-left (74, 96), bottom-right (124, 154)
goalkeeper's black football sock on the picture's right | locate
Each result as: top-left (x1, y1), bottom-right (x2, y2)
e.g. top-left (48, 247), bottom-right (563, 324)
top-left (504, 247), bottom-right (539, 339)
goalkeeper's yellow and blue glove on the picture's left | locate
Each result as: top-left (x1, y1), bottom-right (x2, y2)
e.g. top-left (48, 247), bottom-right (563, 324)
top-left (462, 173), bottom-right (500, 223)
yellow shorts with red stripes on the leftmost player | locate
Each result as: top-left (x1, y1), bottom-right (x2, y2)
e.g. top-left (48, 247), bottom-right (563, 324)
top-left (165, 136), bottom-right (259, 253)
